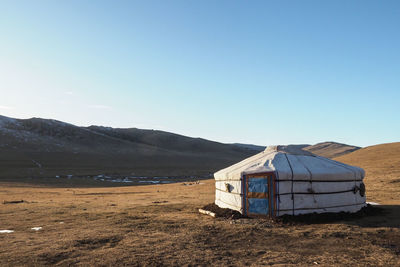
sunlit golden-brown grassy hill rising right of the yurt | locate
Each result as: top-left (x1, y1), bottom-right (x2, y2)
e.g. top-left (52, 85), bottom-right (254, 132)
top-left (334, 142), bottom-right (400, 204)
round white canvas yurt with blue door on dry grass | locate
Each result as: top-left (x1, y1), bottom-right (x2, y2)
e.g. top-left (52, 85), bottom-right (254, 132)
top-left (214, 145), bottom-right (366, 217)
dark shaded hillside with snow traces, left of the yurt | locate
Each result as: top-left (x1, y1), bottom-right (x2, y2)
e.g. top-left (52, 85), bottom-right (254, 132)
top-left (0, 116), bottom-right (255, 177)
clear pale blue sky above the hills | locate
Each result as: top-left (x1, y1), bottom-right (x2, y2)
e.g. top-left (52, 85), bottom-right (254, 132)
top-left (0, 0), bottom-right (400, 146)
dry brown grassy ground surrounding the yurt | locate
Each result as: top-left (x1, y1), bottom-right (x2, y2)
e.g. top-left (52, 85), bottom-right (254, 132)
top-left (0, 143), bottom-right (400, 266)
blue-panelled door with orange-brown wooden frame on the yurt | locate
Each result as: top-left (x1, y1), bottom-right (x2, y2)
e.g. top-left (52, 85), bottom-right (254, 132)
top-left (243, 172), bottom-right (275, 217)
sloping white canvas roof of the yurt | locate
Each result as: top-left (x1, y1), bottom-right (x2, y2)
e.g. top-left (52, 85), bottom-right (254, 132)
top-left (214, 146), bottom-right (365, 181)
